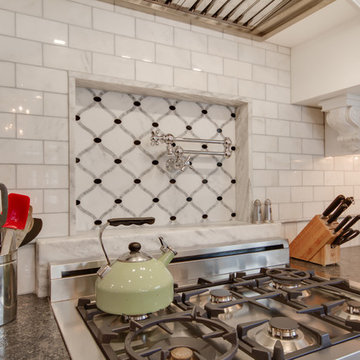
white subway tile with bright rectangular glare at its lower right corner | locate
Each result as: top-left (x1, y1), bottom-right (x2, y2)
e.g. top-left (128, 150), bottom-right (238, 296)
top-left (16, 14), bottom-right (68, 45)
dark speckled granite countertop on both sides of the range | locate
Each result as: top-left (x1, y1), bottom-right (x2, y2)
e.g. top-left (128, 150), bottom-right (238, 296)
top-left (0, 246), bottom-right (360, 360)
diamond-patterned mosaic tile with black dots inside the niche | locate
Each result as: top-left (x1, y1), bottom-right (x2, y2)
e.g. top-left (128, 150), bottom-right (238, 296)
top-left (71, 87), bottom-right (242, 231)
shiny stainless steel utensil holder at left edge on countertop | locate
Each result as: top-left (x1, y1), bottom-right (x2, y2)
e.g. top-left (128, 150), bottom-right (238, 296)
top-left (0, 250), bottom-right (17, 326)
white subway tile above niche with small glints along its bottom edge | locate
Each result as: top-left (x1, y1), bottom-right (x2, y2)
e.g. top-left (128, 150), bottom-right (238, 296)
top-left (115, 36), bottom-right (155, 62)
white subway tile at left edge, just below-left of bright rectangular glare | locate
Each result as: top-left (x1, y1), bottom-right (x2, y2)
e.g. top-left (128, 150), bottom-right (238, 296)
top-left (0, 35), bottom-right (42, 65)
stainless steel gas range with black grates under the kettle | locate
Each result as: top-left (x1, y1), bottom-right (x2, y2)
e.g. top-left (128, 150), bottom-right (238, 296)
top-left (50, 239), bottom-right (360, 360)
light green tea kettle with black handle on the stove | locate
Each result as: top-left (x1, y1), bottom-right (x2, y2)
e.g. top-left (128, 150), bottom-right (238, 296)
top-left (95, 217), bottom-right (176, 315)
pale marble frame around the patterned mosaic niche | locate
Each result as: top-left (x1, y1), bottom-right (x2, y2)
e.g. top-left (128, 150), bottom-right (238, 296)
top-left (69, 72), bottom-right (251, 235)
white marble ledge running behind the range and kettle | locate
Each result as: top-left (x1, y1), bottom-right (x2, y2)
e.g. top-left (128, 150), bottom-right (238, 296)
top-left (36, 221), bottom-right (282, 297)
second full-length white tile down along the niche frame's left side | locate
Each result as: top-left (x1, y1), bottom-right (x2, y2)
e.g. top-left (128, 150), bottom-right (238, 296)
top-left (17, 115), bottom-right (68, 140)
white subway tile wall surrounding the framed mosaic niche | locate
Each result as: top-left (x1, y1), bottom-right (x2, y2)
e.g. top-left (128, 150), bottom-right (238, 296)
top-left (0, 0), bottom-right (360, 293)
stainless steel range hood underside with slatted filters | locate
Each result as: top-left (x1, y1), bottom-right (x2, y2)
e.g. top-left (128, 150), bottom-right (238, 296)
top-left (101, 0), bottom-right (335, 41)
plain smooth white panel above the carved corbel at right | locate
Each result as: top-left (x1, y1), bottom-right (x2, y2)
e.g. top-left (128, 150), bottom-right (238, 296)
top-left (291, 14), bottom-right (360, 104)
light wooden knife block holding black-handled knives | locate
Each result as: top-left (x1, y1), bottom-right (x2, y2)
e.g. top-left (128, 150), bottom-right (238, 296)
top-left (290, 215), bottom-right (340, 266)
